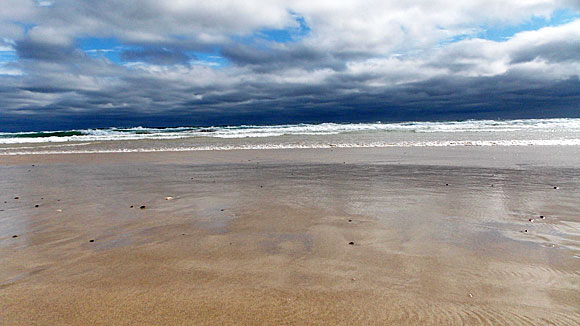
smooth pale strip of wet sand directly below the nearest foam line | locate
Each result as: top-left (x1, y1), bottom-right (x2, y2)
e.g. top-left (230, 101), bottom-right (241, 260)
top-left (0, 146), bottom-right (580, 168)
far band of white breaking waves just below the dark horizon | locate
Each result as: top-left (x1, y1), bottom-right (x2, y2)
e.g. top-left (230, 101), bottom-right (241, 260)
top-left (0, 119), bottom-right (580, 144)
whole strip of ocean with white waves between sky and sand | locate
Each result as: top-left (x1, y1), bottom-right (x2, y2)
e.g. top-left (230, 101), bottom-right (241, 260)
top-left (0, 119), bottom-right (580, 155)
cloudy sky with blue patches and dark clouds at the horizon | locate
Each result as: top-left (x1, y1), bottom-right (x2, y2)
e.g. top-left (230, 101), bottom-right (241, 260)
top-left (0, 0), bottom-right (580, 131)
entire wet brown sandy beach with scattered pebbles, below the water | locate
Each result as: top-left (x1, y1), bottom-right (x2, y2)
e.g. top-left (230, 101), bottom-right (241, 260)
top-left (0, 147), bottom-right (580, 325)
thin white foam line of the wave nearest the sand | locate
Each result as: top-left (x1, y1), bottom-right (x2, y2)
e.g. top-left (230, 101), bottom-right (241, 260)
top-left (0, 139), bottom-right (580, 155)
